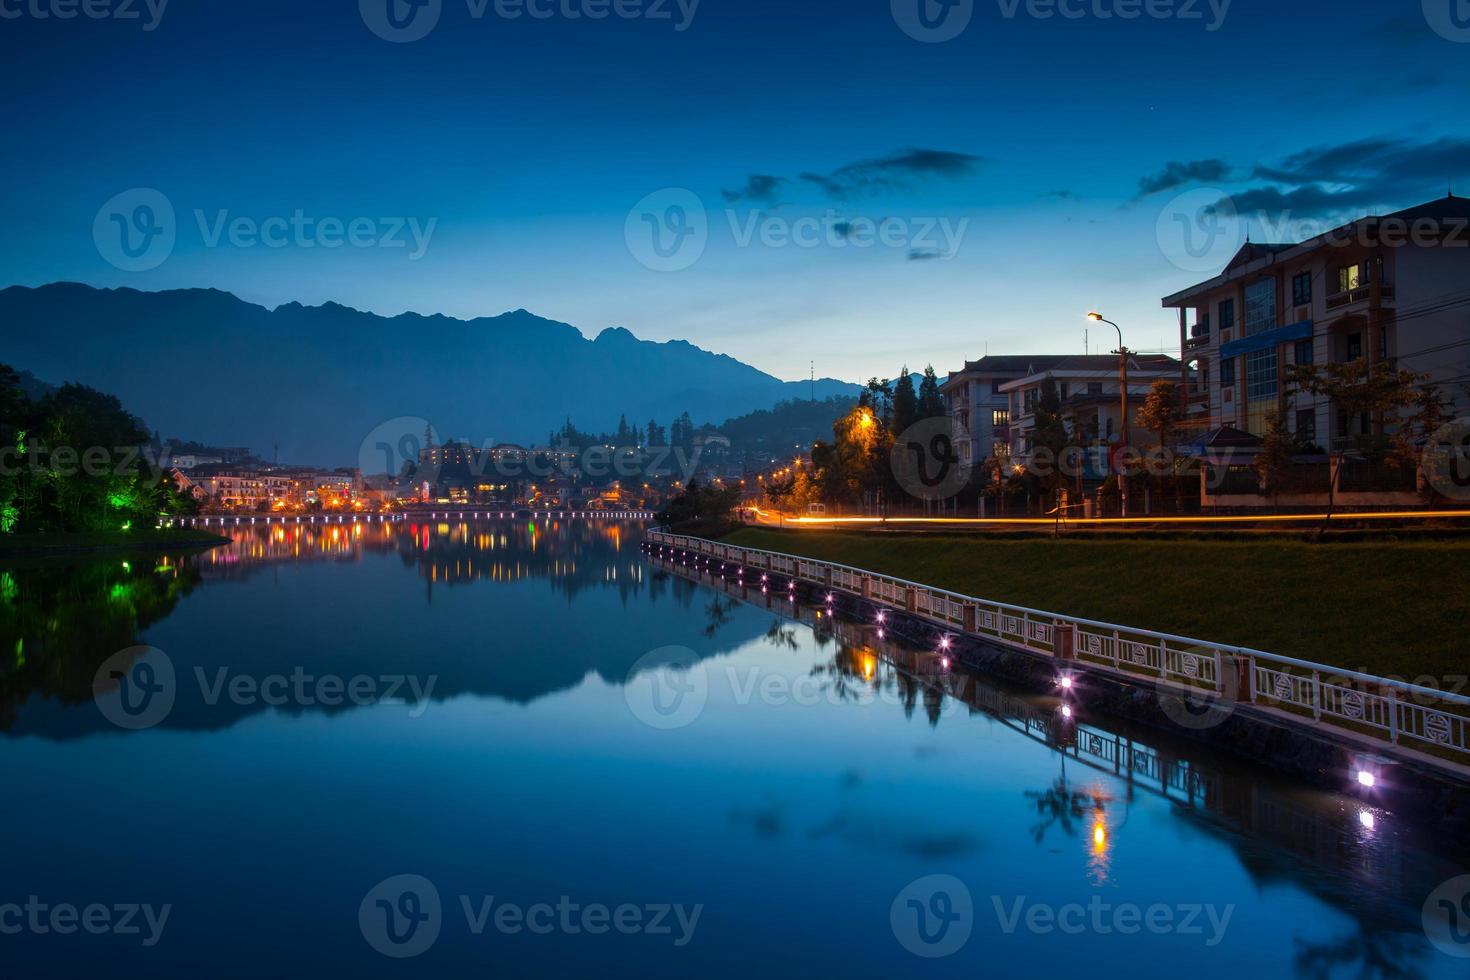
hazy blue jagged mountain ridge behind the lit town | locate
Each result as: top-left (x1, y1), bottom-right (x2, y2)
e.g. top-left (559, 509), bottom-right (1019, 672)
top-left (0, 282), bottom-right (858, 466)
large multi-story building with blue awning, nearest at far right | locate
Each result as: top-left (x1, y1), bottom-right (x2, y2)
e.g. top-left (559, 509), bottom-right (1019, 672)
top-left (1163, 197), bottom-right (1470, 448)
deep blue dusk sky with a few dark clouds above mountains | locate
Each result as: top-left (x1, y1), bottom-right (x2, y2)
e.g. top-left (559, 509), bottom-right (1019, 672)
top-left (0, 0), bottom-right (1470, 379)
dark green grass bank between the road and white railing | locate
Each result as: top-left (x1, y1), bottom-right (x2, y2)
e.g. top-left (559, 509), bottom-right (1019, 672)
top-left (725, 527), bottom-right (1470, 689)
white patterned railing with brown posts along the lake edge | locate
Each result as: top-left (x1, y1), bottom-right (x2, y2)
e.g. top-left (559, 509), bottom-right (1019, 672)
top-left (647, 527), bottom-right (1470, 761)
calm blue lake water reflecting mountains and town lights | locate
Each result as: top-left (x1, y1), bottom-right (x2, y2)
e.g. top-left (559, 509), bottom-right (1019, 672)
top-left (0, 522), bottom-right (1470, 979)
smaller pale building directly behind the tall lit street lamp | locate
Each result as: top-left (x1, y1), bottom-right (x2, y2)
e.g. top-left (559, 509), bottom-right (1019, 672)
top-left (998, 354), bottom-right (1179, 473)
